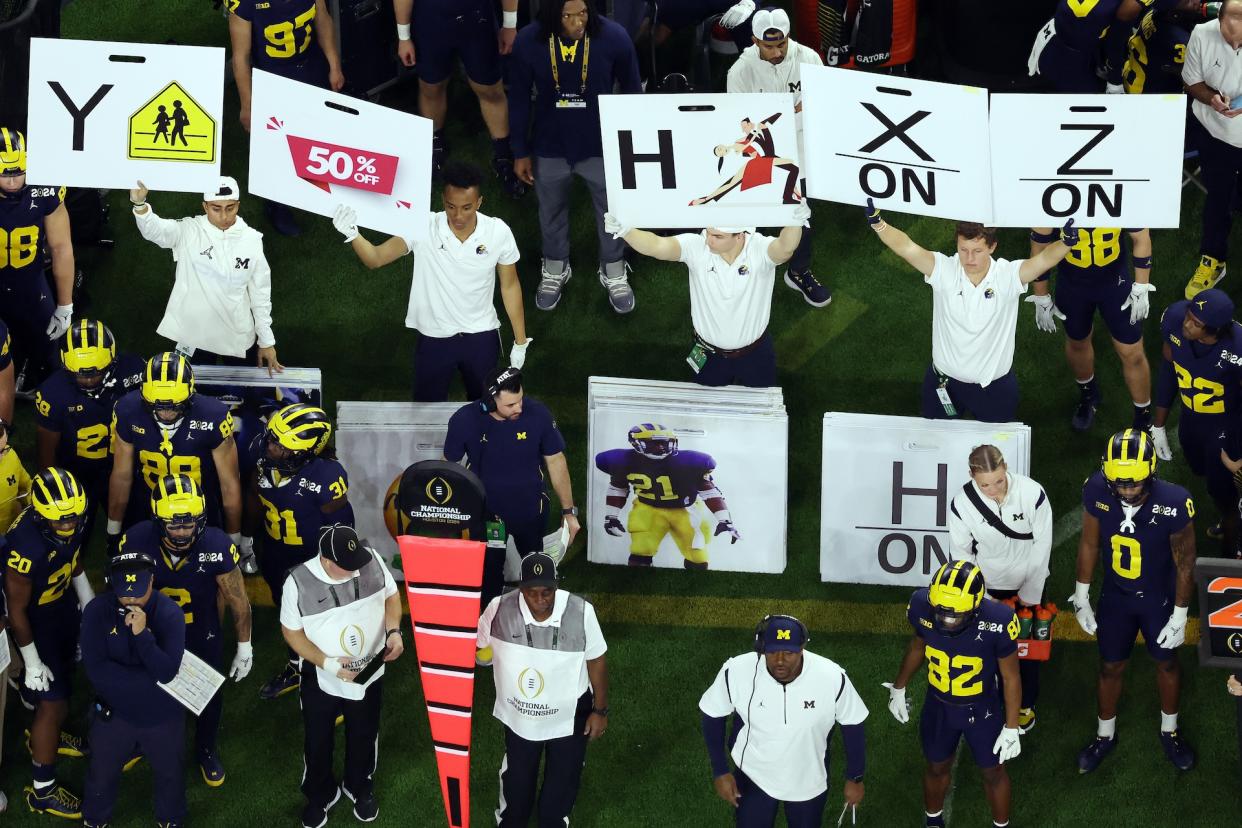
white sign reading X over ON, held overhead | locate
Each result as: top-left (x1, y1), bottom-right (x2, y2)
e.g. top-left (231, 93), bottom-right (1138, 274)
top-left (802, 66), bottom-right (992, 223)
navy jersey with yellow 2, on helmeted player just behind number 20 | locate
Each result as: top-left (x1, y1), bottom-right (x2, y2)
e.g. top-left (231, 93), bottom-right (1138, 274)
top-left (35, 354), bottom-right (145, 479)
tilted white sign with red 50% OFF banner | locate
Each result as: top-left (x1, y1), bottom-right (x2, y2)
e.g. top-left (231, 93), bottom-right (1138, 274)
top-left (250, 70), bottom-right (431, 240)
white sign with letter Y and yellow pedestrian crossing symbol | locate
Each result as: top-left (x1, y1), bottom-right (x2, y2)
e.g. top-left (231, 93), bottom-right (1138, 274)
top-left (26, 37), bottom-right (225, 192)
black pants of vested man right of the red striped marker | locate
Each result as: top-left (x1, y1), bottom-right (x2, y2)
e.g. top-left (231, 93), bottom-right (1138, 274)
top-left (496, 690), bottom-right (594, 828)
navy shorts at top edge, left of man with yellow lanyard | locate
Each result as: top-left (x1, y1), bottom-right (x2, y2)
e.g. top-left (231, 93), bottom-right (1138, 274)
top-left (414, 0), bottom-right (501, 86)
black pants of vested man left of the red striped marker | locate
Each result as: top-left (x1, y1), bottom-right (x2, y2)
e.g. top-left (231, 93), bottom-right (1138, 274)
top-left (301, 660), bottom-right (384, 807)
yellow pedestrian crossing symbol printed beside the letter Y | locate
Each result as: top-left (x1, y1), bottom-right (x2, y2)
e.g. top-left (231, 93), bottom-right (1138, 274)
top-left (129, 81), bottom-right (216, 163)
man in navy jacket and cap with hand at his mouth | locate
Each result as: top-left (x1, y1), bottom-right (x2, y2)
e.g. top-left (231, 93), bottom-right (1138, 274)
top-left (82, 552), bottom-right (186, 826)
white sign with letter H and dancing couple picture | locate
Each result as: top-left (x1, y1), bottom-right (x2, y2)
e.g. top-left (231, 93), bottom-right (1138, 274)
top-left (600, 94), bottom-right (804, 227)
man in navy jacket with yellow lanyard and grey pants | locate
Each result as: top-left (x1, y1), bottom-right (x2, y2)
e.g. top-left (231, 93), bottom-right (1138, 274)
top-left (509, 0), bottom-right (641, 313)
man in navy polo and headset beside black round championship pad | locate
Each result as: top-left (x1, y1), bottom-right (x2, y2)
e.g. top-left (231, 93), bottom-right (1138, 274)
top-left (445, 367), bottom-right (579, 607)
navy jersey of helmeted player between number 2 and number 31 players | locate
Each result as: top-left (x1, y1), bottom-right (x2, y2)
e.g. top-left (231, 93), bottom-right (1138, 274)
top-left (112, 390), bottom-right (232, 500)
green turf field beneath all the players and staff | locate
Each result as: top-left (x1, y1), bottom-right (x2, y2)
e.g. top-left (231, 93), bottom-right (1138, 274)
top-left (0, 0), bottom-right (1242, 828)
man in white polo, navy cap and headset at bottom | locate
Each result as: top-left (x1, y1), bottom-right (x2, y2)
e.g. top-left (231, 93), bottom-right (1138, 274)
top-left (699, 616), bottom-right (867, 828)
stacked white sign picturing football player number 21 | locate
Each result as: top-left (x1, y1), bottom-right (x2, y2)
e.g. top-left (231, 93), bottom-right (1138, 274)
top-left (584, 376), bottom-right (789, 572)
